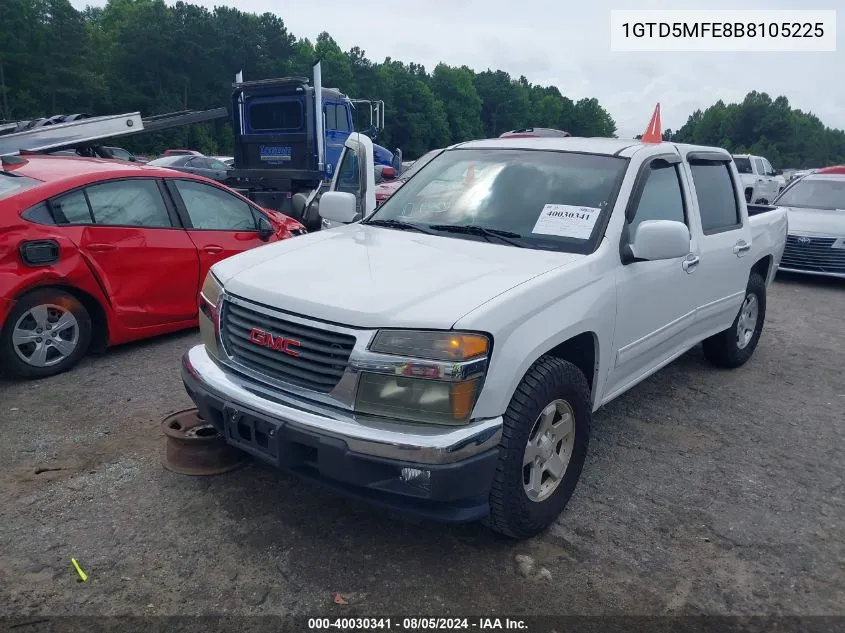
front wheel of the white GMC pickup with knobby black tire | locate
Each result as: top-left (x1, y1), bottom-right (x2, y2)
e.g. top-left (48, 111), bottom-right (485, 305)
top-left (489, 356), bottom-right (592, 538)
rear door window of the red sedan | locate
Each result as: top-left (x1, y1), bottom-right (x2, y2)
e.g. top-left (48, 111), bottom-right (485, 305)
top-left (87, 180), bottom-right (171, 228)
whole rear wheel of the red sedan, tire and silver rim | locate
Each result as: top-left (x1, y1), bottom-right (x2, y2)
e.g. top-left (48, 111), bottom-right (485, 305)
top-left (0, 288), bottom-right (91, 378)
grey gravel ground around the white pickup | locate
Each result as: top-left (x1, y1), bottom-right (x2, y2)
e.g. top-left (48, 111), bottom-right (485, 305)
top-left (0, 277), bottom-right (845, 615)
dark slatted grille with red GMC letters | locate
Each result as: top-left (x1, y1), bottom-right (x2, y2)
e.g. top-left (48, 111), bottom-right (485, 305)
top-left (220, 301), bottom-right (355, 393)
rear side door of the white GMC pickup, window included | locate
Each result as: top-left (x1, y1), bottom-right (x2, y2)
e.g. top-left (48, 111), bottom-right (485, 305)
top-left (686, 151), bottom-right (759, 336)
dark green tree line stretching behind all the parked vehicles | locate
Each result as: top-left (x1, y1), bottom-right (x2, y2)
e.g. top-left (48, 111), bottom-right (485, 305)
top-left (0, 0), bottom-right (845, 167)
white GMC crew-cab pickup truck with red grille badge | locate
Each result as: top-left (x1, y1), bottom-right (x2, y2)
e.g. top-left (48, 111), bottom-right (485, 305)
top-left (182, 134), bottom-right (787, 538)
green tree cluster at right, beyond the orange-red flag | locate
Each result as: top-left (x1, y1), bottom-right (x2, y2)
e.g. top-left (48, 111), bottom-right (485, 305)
top-left (663, 91), bottom-right (845, 169)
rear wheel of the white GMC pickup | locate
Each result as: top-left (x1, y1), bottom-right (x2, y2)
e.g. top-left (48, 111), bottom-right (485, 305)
top-left (703, 273), bottom-right (766, 369)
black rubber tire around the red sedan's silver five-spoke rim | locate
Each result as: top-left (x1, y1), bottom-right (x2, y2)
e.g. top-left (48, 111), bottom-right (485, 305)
top-left (0, 288), bottom-right (91, 378)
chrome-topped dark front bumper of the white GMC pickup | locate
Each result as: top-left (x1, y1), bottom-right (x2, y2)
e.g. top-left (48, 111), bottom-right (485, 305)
top-left (182, 345), bottom-right (502, 522)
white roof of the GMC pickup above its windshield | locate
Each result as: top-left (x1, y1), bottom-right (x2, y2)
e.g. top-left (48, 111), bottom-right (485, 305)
top-left (449, 136), bottom-right (730, 158)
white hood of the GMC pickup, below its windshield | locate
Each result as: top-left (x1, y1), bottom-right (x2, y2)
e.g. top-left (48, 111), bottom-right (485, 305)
top-left (212, 223), bottom-right (584, 329)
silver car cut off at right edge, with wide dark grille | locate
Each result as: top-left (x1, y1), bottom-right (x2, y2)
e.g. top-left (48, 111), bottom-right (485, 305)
top-left (774, 174), bottom-right (845, 279)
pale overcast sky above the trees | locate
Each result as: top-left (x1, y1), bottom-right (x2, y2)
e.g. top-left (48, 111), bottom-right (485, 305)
top-left (71, 0), bottom-right (845, 137)
